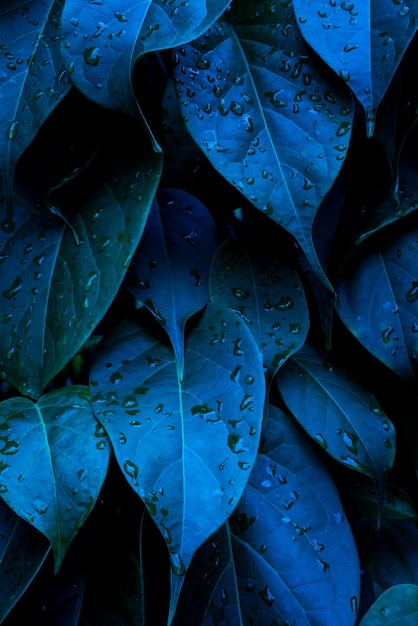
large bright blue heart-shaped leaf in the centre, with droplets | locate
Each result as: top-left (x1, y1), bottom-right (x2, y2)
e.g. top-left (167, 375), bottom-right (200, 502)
top-left (90, 305), bottom-right (265, 617)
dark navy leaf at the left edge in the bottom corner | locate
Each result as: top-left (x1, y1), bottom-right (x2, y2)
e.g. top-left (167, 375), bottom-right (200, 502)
top-left (0, 500), bottom-right (50, 623)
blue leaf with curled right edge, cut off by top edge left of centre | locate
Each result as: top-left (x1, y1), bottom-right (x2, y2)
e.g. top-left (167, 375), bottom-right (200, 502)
top-left (62, 0), bottom-right (229, 121)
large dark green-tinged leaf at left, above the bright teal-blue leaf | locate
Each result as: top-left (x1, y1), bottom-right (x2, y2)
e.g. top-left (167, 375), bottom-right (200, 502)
top-left (0, 140), bottom-right (161, 397)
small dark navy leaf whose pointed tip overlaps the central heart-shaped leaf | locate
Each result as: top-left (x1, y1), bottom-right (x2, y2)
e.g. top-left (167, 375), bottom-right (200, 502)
top-left (126, 189), bottom-right (218, 378)
